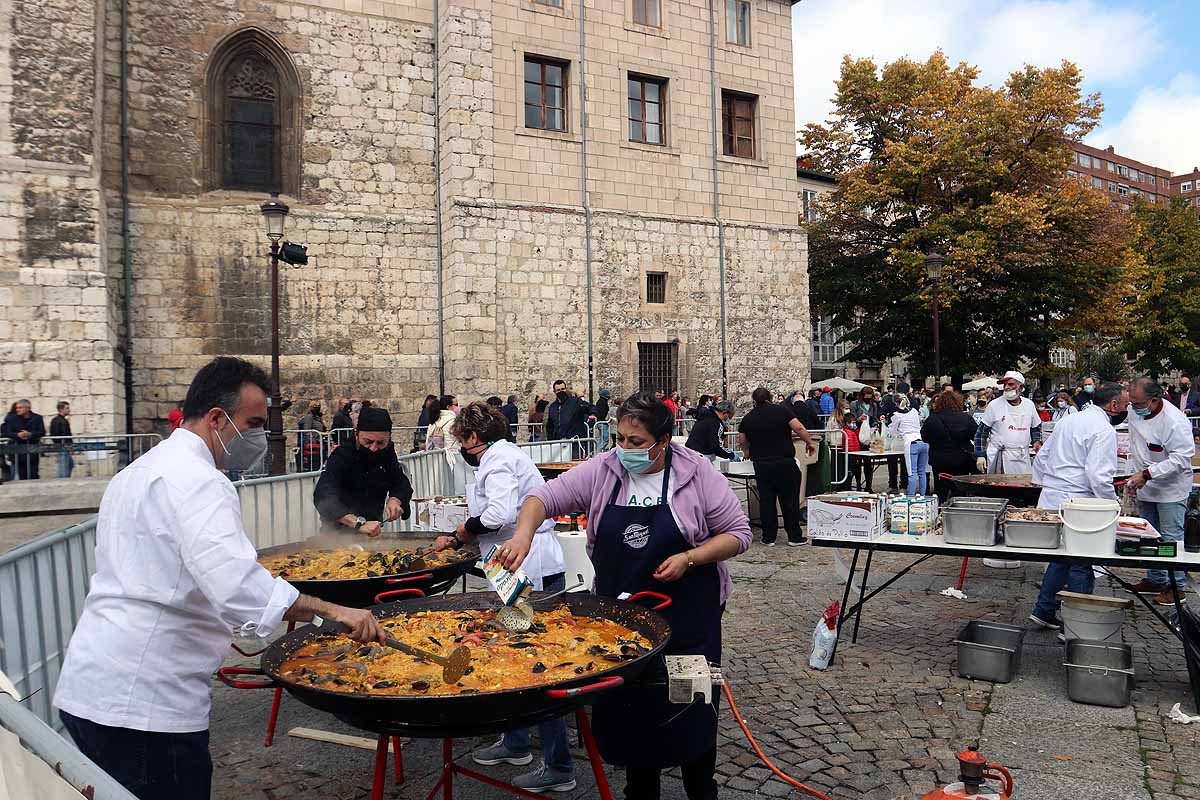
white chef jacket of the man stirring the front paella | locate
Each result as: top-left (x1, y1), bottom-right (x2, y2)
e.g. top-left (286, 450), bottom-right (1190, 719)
top-left (54, 428), bottom-right (300, 733)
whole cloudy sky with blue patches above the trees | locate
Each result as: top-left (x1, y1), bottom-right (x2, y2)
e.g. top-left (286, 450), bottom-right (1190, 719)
top-left (792, 0), bottom-right (1200, 173)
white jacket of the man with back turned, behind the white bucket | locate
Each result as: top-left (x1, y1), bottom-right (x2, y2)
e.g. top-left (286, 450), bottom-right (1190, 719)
top-left (1033, 404), bottom-right (1117, 509)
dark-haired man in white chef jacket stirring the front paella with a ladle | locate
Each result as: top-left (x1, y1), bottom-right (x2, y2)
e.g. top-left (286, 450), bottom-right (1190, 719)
top-left (54, 357), bottom-right (384, 800)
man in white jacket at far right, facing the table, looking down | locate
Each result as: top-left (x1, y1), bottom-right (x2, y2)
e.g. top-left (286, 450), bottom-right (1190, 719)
top-left (1127, 378), bottom-right (1196, 606)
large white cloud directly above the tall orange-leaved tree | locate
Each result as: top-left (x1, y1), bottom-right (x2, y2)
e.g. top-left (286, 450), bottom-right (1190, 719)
top-left (792, 0), bottom-right (1166, 146)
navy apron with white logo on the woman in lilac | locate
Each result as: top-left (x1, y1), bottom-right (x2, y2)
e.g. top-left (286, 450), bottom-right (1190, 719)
top-left (592, 449), bottom-right (721, 769)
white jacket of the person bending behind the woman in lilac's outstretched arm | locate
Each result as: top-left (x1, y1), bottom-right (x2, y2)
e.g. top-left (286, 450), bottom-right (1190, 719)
top-left (467, 440), bottom-right (566, 591)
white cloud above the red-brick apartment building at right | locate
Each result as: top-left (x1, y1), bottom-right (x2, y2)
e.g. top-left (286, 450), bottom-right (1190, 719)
top-left (1086, 72), bottom-right (1200, 174)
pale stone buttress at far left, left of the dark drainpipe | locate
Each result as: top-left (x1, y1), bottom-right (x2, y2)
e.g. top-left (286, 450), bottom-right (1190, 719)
top-left (0, 0), bottom-right (124, 433)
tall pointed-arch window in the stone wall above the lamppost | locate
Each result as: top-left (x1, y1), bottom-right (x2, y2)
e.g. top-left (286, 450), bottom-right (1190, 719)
top-left (205, 29), bottom-right (301, 194)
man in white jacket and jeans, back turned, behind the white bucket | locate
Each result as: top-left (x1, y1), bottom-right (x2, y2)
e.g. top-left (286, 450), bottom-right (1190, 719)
top-left (1030, 384), bottom-right (1129, 631)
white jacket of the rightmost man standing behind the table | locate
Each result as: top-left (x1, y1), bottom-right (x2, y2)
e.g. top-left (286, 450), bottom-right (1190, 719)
top-left (1126, 401), bottom-right (1196, 503)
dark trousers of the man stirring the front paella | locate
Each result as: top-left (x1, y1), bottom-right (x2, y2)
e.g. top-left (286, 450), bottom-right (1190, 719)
top-left (59, 711), bottom-right (212, 800)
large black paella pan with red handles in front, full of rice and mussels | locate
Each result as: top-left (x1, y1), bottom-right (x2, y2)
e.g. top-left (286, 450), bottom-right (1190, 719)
top-left (220, 593), bottom-right (671, 738)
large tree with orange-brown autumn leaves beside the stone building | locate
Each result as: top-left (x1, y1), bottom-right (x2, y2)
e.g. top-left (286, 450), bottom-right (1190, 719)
top-left (800, 52), bottom-right (1126, 383)
